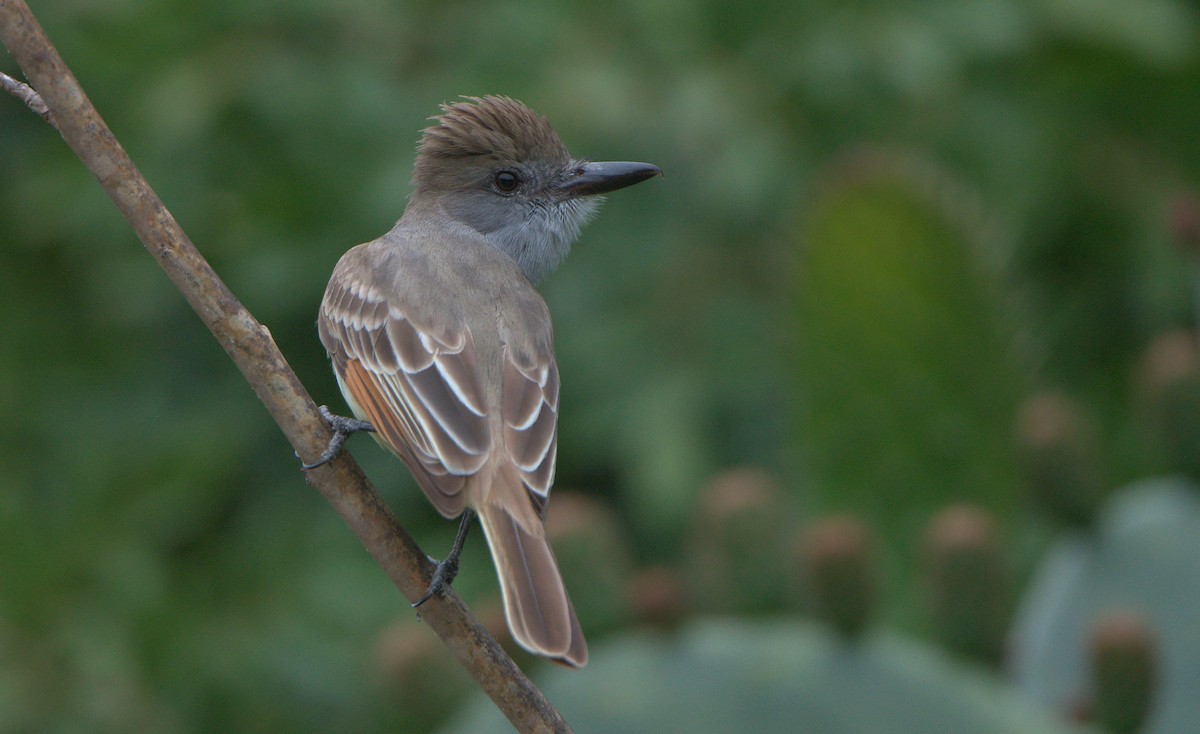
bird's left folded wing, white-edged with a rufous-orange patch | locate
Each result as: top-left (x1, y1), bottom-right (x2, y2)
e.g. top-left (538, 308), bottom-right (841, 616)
top-left (318, 275), bottom-right (492, 517)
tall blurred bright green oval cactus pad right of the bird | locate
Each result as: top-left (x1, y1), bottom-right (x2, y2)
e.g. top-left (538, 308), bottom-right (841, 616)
top-left (793, 151), bottom-right (1021, 547)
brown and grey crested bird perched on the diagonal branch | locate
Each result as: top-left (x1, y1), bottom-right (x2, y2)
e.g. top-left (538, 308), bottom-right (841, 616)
top-left (306, 96), bottom-right (662, 667)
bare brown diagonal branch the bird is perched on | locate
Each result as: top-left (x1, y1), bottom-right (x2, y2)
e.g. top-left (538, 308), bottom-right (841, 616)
top-left (0, 0), bottom-right (570, 732)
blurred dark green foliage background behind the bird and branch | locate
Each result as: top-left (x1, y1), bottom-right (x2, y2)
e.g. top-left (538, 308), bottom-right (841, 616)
top-left (0, 0), bottom-right (1200, 732)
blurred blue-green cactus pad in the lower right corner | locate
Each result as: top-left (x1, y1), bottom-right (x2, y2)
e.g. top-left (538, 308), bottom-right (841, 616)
top-left (1010, 479), bottom-right (1200, 734)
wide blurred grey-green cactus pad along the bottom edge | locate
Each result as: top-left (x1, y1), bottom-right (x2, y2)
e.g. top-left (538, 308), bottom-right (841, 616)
top-left (445, 620), bottom-right (1068, 734)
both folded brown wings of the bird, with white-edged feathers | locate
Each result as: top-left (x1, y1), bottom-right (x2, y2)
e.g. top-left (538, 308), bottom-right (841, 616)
top-left (318, 255), bottom-right (559, 517)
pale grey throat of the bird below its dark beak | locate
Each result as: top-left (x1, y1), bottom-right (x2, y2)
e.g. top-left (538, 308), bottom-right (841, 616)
top-left (484, 195), bottom-right (604, 284)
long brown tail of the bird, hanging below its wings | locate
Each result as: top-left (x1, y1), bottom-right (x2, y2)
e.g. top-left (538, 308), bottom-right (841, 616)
top-left (475, 503), bottom-right (588, 668)
